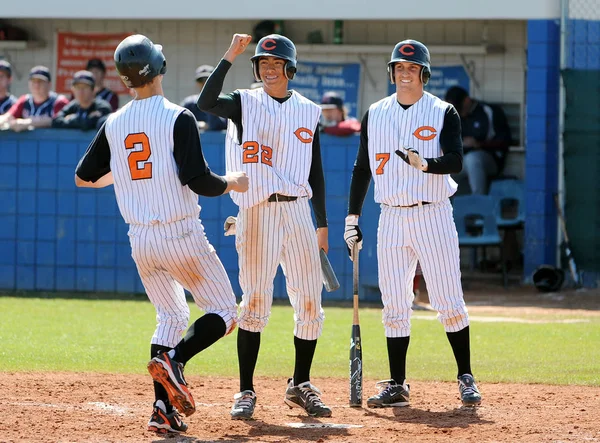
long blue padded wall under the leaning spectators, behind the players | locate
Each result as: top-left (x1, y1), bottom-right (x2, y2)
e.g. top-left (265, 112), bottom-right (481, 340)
top-left (0, 129), bottom-right (379, 300)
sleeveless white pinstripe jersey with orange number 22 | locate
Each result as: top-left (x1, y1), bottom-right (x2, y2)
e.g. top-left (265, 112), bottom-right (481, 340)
top-left (225, 88), bottom-right (321, 208)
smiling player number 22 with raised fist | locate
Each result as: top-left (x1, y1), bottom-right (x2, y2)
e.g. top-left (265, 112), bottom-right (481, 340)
top-left (198, 34), bottom-right (331, 420)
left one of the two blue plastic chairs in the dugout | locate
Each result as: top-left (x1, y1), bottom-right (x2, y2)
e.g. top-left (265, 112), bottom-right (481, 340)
top-left (452, 195), bottom-right (508, 288)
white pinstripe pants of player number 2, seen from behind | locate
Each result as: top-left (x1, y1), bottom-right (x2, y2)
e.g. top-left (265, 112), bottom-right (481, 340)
top-left (129, 217), bottom-right (237, 348)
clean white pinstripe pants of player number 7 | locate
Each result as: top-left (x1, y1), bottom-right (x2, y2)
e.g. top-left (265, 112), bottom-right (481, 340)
top-left (377, 200), bottom-right (469, 337)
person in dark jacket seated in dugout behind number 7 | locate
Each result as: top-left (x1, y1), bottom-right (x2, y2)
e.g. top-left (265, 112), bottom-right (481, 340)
top-left (445, 86), bottom-right (511, 194)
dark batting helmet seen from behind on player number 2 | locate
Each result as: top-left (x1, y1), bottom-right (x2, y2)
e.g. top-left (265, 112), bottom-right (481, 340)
top-left (115, 34), bottom-right (167, 88)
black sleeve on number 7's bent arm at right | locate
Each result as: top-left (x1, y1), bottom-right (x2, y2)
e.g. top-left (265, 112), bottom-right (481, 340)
top-left (425, 105), bottom-right (463, 174)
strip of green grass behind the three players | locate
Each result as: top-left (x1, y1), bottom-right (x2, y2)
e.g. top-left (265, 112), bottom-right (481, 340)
top-left (0, 297), bottom-right (600, 386)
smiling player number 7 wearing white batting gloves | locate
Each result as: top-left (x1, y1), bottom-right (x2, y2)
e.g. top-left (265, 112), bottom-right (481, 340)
top-left (344, 40), bottom-right (481, 407)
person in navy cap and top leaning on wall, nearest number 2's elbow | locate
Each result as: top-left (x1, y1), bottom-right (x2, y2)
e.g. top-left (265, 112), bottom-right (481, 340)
top-left (52, 71), bottom-right (112, 131)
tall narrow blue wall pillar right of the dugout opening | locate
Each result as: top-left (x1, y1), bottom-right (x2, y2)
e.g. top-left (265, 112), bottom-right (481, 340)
top-left (523, 20), bottom-right (560, 281)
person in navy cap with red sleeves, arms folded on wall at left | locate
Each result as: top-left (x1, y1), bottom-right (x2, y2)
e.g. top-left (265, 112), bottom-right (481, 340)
top-left (0, 66), bottom-right (69, 132)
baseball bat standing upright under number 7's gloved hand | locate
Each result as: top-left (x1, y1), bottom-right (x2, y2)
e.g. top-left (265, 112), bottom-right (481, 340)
top-left (350, 244), bottom-right (362, 408)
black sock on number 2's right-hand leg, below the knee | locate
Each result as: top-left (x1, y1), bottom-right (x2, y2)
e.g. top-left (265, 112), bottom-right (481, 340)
top-left (175, 314), bottom-right (227, 365)
